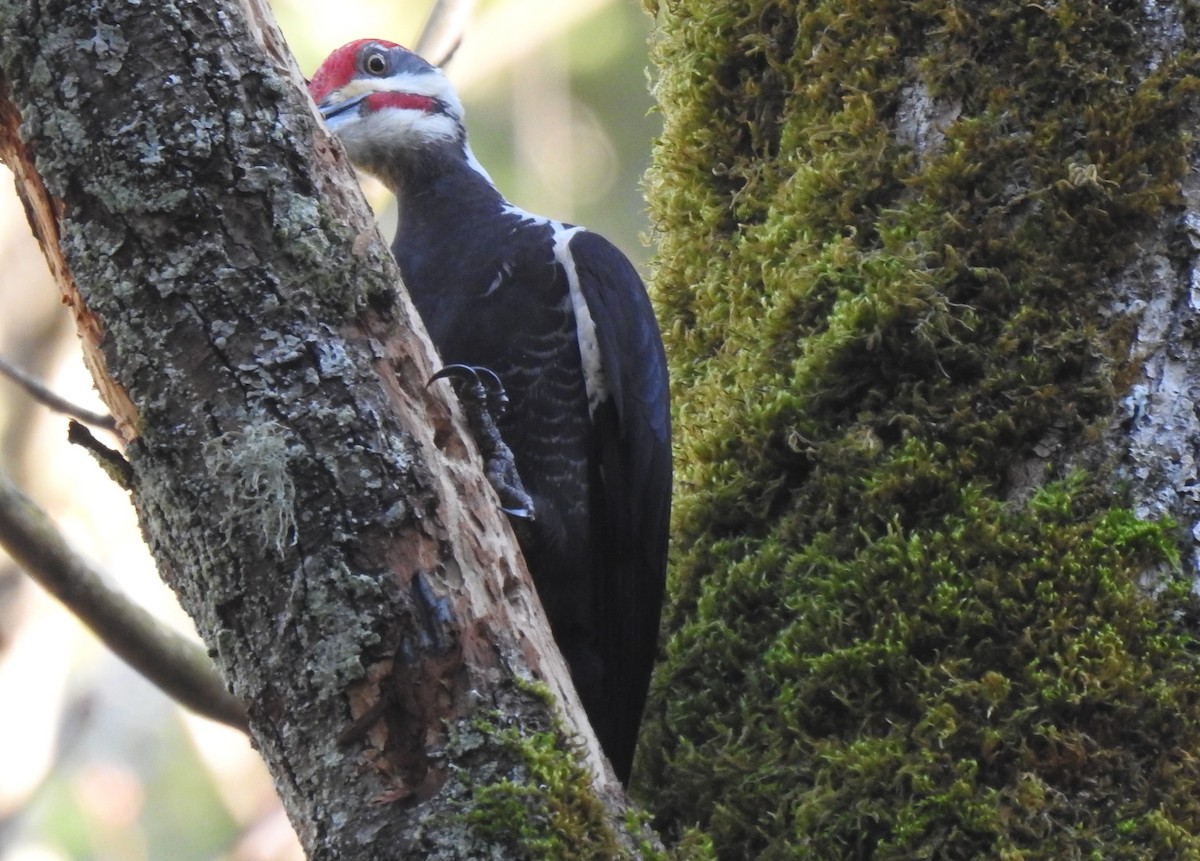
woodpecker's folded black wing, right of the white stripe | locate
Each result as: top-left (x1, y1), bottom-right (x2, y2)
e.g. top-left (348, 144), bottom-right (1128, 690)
top-left (569, 231), bottom-right (671, 782)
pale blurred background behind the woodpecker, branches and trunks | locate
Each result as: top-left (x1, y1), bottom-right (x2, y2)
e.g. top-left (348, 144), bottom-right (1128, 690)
top-left (0, 0), bottom-right (658, 861)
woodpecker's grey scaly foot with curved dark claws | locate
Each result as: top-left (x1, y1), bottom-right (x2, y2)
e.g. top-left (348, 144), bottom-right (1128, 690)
top-left (430, 365), bottom-right (534, 520)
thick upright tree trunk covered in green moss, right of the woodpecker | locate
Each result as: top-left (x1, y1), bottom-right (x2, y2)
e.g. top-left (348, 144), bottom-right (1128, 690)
top-left (643, 0), bottom-right (1200, 861)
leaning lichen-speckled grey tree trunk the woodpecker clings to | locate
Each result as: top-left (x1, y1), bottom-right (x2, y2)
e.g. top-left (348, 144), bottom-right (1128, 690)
top-left (0, 0), bottom-right (643, 859)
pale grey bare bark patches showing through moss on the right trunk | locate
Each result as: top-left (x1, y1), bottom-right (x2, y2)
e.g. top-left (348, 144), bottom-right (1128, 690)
top-left (895, 15), bottom-right (1200, 584)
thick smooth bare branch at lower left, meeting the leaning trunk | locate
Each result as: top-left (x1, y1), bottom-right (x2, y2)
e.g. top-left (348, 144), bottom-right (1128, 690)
top-left (0, 472), bottom-right (247, 731)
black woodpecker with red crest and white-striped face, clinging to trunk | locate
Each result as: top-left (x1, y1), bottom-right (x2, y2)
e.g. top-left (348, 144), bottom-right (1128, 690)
top-left (308, 40), bottom-right (671, 782)
